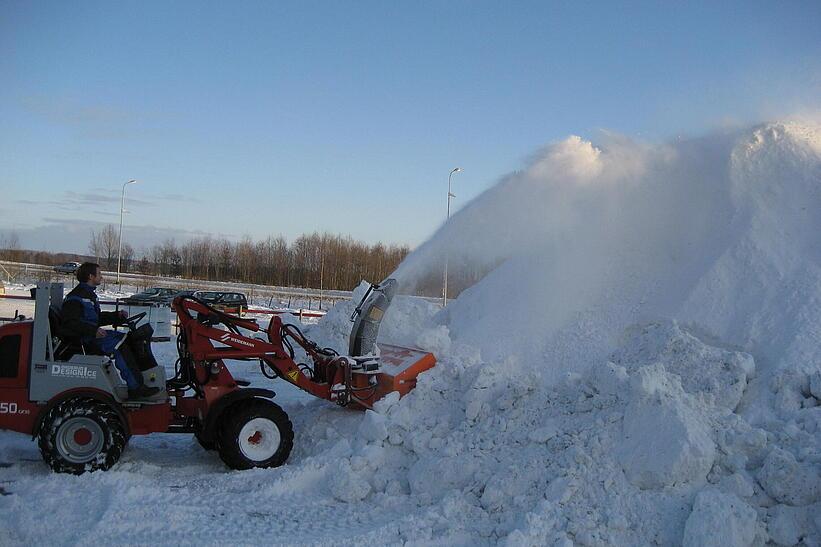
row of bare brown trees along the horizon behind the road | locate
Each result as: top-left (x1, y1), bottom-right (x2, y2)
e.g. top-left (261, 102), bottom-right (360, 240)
top-left (0, 230), bottom-right (486, 298)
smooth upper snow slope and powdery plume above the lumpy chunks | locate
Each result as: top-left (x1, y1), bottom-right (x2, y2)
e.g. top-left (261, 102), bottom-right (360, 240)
top-left (396, 122), bottom-right (821, 384)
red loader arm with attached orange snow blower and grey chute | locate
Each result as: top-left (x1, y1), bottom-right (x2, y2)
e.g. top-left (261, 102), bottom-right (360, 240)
top-left (173, 279), bottom-right (436, 408)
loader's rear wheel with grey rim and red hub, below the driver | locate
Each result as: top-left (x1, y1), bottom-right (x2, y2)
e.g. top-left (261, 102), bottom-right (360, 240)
top-left (37, 397), bottom-right (128, 475)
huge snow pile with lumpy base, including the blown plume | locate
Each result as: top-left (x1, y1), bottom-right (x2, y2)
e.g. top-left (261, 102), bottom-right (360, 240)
top-left (310, 122), bottom-right (821, 545)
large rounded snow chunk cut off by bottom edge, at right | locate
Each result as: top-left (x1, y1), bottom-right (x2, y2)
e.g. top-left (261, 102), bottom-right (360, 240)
top-left (683, 489), bottom-right (757, 547)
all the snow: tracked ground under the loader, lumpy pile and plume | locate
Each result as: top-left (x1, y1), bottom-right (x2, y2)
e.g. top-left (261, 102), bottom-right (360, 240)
top-left (0, 122), bottom-right (821, 545)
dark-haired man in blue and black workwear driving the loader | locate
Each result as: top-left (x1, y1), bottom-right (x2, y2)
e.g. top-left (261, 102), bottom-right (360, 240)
top-left (60, 262), bottom-right (160, 399)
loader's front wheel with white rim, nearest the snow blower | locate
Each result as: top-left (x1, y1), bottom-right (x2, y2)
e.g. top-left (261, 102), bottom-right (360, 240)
top-left (217, 399), bottom-right (294, 469)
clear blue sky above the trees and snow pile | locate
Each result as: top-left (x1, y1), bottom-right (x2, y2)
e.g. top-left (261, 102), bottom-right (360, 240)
top-left (0, 1), bottom-right (821, 255)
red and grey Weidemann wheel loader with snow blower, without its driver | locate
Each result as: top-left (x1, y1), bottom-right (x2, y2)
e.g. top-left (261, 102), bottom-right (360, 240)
top-left (0, 279), bottom-right (436, 474)
